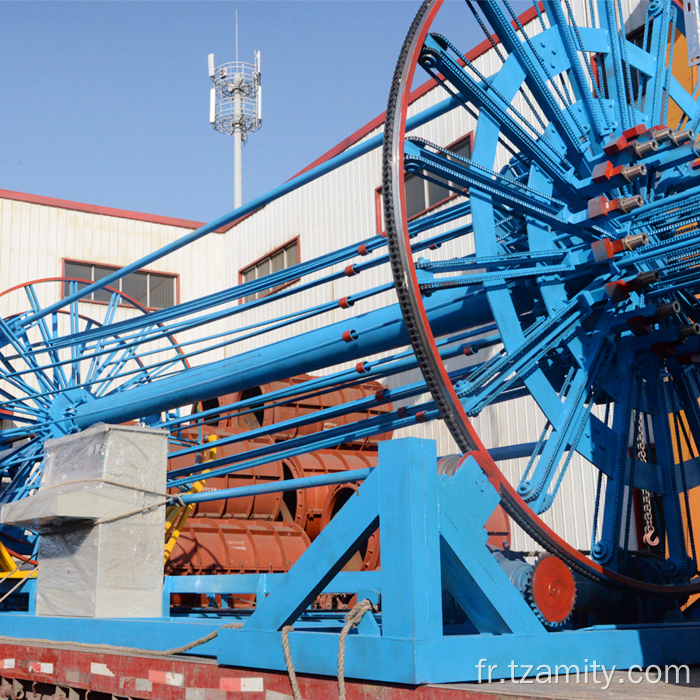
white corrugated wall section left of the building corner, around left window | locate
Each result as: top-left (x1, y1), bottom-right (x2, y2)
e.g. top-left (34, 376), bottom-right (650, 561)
top-left (0, 198), bottom-right (232, 394)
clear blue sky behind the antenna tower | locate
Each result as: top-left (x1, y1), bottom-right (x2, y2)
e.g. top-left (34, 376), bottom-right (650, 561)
top-left (0, 0), bottom-right (523, 221)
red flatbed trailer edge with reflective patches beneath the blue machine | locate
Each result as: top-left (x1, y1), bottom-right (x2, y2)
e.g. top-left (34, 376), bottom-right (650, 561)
top-left (0, 643), bottom-right (700, 700)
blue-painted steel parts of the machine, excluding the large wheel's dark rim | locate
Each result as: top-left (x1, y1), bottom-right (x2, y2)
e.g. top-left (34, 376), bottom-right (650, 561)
top-left (0, 1), bottom-right (700, 683)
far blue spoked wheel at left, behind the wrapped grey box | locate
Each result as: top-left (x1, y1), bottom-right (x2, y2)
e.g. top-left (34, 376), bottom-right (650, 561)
top-left (0, 277), bottom-right (189, 502)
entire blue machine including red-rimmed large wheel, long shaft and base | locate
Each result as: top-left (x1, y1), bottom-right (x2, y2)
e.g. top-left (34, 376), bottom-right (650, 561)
top-left (0, 0), bottom-right (700, 684)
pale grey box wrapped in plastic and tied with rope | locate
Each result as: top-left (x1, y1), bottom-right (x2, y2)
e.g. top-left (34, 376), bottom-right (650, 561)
top-left (0, 423), bottom-right (167, 617)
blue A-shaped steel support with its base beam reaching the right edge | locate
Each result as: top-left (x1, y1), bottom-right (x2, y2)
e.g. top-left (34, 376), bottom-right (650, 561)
top-left (217, 438), bottom-right (700, 684)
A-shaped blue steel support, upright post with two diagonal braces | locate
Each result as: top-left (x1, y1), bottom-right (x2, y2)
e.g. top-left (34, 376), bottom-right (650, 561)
top-left (219, 438), bottom-right (544, 681)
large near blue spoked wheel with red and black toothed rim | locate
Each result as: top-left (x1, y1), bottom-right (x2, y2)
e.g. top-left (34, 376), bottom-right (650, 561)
top-left (383, 0), bottom-right (700, 597)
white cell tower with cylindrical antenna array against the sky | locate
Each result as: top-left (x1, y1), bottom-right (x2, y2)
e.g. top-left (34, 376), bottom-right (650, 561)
top-left (208, 28), bottom-right (262, 209)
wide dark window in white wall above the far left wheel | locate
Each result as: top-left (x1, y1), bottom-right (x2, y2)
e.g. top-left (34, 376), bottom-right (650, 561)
top-left (63, 260), bottom-right (177, 309)
